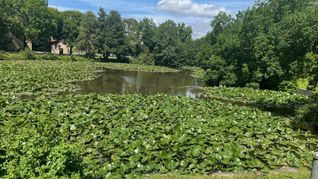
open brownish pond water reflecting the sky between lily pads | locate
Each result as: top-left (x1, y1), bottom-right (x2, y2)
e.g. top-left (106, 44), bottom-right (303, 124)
top-left (76, 70), bottom-right (205, 98)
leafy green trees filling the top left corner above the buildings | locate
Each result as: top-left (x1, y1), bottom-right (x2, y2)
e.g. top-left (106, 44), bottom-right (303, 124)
top-left (0, 0), bottom-right (55, 50)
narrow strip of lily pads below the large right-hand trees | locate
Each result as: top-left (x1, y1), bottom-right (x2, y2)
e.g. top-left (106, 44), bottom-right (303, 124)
top-left (204, 87), bottom-right (308, 105)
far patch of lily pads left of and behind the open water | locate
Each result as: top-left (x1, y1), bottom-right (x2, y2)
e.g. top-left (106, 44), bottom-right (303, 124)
top-left (0, 61), bottom-right (176, 95)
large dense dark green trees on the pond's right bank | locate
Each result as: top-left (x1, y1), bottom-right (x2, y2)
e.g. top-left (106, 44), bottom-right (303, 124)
top-left (196, 0), bottom-right (318, 89)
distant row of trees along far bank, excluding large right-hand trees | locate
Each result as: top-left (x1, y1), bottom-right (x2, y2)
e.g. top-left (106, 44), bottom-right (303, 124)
top-left (0, 0), bottom-right (194, 67)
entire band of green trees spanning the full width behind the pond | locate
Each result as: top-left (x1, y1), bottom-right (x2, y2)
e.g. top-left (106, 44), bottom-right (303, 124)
top-left (0, 0), bottom-right (318, 89)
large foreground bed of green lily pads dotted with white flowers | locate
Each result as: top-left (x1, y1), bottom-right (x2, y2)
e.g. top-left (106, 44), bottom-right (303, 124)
top-left (0, 95), bottom-right (318, 178)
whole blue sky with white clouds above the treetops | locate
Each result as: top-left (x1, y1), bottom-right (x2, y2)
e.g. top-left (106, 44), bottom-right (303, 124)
top-left (49, 0), bottom-right (254, 39)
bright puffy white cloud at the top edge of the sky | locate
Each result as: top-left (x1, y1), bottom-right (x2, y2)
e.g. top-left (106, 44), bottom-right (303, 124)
top-left (157, 0), bottom-right (226, 17)
